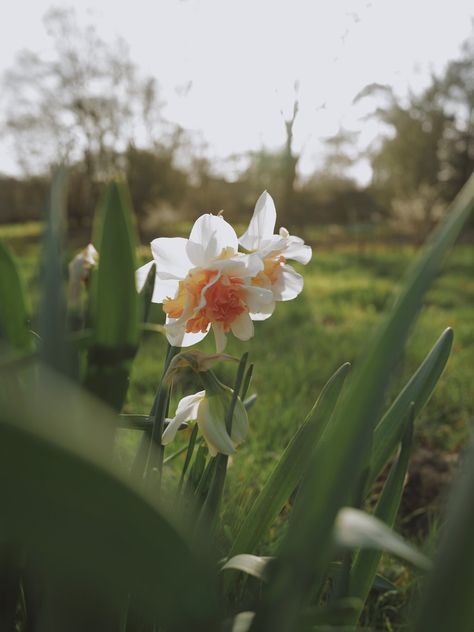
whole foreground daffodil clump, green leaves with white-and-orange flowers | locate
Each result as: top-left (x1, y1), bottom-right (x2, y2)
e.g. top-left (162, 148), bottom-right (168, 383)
top-left (0, 170), bottom-right (474, 632)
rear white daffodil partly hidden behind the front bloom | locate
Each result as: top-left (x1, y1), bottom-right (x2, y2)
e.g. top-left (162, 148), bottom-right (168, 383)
top-left (239, 191), bottom-right (312, 320)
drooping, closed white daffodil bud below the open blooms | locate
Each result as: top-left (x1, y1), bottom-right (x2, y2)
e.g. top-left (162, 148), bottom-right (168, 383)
top-left (161, 387), bottom-right (248, 456)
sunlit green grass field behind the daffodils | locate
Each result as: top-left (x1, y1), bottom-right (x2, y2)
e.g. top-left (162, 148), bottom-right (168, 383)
top-left (0, 227), bottom-right (474, 629)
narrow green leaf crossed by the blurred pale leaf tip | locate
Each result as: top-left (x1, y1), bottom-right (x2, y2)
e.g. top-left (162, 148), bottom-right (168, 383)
top-left (347, 414), bottom-right (414, 624)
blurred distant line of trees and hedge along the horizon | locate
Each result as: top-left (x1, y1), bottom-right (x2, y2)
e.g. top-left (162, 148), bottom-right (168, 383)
top-left (0, 9), bottom-right (474, 234)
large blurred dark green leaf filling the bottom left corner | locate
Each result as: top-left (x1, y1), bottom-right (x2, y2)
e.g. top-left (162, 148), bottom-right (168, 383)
top-left (0, 372), bottom-right (218, 632)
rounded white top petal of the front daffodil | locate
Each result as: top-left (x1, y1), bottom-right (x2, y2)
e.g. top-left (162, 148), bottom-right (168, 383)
top-left (186, 213), bottom-right (239, 267)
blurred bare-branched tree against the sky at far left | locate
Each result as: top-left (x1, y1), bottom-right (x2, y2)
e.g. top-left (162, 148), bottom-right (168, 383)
top-left (3, 8), bottom-right (160, 182)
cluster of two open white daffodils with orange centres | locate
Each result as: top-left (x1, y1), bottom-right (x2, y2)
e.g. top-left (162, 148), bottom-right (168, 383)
top-left (137, 191), bottom-right (311, 353)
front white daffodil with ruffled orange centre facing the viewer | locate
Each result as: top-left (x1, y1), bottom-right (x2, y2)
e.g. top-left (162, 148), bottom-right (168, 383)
top-left (137, 213), bottom-right (273, 353)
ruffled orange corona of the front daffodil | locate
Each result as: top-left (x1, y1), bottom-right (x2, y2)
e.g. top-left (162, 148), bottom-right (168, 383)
top-left (163, 269), bottom-right (248, 333)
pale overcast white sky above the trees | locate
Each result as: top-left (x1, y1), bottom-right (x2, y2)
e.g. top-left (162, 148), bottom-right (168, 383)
top-left (0, 0), bottom-right (474, 181)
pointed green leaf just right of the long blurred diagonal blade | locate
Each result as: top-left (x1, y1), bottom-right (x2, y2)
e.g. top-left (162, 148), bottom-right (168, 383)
top-left (367, 327), bottom-right (454, 490)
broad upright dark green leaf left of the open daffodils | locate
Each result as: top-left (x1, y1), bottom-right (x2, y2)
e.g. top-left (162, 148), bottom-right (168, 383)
top-left (86, 180), bottom-right (141, 410)
